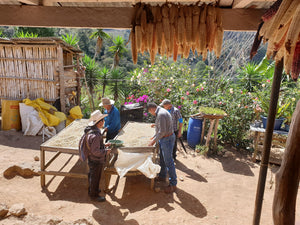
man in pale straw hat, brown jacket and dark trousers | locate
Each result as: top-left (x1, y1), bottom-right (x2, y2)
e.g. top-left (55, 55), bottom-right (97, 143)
top-left (79, 110), bottom-right (110, 202)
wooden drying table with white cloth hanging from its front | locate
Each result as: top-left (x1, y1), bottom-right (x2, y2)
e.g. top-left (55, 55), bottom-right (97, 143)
top-left (104, 122), bottom-right (158, 191)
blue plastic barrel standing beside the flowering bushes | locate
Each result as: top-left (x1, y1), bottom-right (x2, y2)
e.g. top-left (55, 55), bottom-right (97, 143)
top-left (187, 117), bottom-right (203, 148)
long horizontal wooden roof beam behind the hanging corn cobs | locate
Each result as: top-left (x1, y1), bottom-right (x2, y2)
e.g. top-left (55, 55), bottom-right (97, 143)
top-left (0, 5), bottom-right (264, 31)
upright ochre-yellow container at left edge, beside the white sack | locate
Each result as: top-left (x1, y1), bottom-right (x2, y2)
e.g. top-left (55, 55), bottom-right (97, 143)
top-left (1, 100), bottom-right (21, 130)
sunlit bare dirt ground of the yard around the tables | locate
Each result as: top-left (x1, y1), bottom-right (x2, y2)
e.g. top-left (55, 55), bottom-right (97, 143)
top-left (0, 131), bottom-right (300, 225)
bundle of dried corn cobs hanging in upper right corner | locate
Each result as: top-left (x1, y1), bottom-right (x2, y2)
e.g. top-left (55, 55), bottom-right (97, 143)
top-left (250, 0), bottom-right (300, 81)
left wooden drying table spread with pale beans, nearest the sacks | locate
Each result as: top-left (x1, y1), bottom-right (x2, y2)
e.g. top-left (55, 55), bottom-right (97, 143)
top-left (40, 119), bottom-right (88, 187)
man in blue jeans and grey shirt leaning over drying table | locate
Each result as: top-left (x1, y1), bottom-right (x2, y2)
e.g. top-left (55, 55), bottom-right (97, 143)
top-left (147, 102), bottom-right (177, 193)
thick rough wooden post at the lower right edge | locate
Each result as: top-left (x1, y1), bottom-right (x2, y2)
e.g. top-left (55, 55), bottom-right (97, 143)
top-left (273, 100), bottom-right (300, 225)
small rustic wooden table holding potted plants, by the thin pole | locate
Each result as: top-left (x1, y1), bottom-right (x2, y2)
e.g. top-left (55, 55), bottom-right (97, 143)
top-left (250, 126), bottom-right (288, 162)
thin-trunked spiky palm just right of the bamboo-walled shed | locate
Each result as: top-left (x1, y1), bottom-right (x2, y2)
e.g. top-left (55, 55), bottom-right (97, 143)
top-left (83, 55), bottom-right (99, 111)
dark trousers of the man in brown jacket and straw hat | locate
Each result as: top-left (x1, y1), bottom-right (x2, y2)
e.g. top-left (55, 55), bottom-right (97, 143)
top-left (88, 159), bottom-right (103, 197)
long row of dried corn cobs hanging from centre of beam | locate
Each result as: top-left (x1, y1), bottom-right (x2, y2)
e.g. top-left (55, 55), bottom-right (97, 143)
top-left (130, 3), bottom-right (223, 64)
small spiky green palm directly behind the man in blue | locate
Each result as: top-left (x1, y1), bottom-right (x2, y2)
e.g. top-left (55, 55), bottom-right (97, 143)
top-left (109, 69), bottom-right (125, 101)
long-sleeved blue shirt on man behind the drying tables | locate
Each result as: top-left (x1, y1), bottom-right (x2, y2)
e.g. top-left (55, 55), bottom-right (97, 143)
top-left (104, 105), bottom-right (121, 133)
